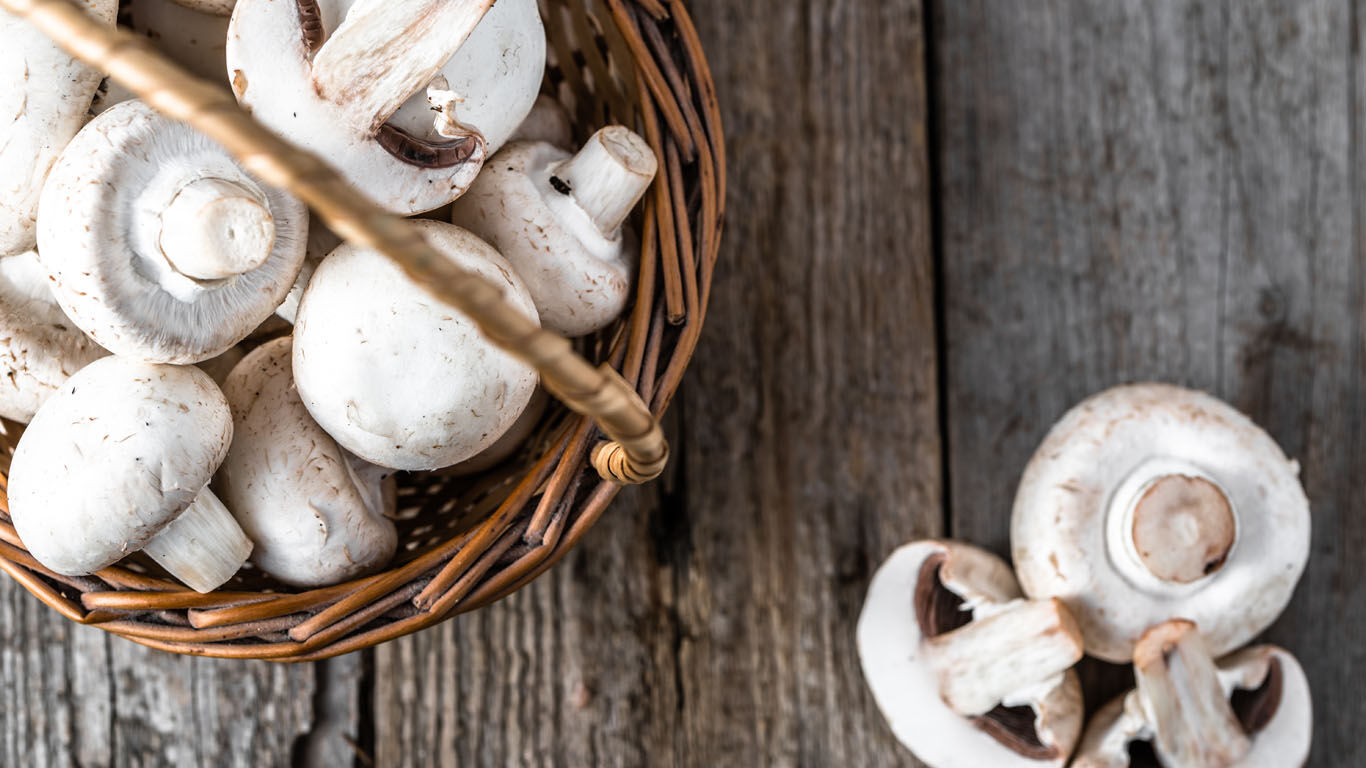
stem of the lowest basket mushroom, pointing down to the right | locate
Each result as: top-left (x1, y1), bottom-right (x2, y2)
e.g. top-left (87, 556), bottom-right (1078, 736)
top-left (142, 488), bottom-right (251, 593)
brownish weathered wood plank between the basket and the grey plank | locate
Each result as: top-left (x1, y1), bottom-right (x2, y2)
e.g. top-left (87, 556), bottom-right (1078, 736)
top-left (373, 0), bottom-right (943, 767)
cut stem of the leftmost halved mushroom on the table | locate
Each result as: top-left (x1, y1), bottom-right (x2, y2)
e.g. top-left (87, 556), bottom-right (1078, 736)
top-left (928, 599), bottom-right (1082, 716)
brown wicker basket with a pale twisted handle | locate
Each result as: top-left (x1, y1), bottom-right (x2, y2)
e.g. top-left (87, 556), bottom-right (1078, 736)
top-left (0, 0), bottom-right (725, 661)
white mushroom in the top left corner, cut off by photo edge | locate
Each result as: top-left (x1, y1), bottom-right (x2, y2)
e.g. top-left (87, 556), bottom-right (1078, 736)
top-left (0, 0), bottom-right (119, 256)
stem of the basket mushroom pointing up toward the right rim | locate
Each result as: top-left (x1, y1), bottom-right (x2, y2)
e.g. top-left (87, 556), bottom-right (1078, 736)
top-left (550, 126), bottom-right (658, 238)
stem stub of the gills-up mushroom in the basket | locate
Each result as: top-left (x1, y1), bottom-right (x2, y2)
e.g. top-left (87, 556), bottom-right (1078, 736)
top-left (158, 179), bottom-right (275, 280)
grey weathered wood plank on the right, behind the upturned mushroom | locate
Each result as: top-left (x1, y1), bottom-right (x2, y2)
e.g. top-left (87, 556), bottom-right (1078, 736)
top-left (933, 0), bottom-right (1366, 765)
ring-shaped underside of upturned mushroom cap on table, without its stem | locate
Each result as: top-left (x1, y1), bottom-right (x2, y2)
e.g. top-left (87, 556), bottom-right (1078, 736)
top-left (1011, 384), bottom-right (1310, 663)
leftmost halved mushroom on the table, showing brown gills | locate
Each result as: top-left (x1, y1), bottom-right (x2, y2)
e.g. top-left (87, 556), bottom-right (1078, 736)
top-left (858, 541), bottom-right (1082, 768)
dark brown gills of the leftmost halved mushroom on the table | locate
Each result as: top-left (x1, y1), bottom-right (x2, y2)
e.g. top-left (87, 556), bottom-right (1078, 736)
top-left (914, 555), bottom-right (1059, 760)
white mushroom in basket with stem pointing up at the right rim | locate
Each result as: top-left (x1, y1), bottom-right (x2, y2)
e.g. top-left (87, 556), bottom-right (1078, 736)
top-left (451, 126), bottom-right (658, 336)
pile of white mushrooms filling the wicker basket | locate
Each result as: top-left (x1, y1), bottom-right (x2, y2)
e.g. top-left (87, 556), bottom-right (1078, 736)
top-left (0, 0), bottom-right (658, 592)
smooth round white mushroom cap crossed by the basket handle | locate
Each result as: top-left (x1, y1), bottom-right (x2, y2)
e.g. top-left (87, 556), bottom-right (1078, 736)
top-left (294, 220), bottom-right (537, 470)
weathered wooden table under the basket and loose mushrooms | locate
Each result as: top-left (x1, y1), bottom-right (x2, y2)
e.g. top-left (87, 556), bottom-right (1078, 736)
top-left (0, 0), bottom-right (1366, 768)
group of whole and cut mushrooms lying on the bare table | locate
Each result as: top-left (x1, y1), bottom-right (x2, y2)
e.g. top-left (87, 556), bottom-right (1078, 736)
top-left (858, 384), bottom-right (1313, 768)
